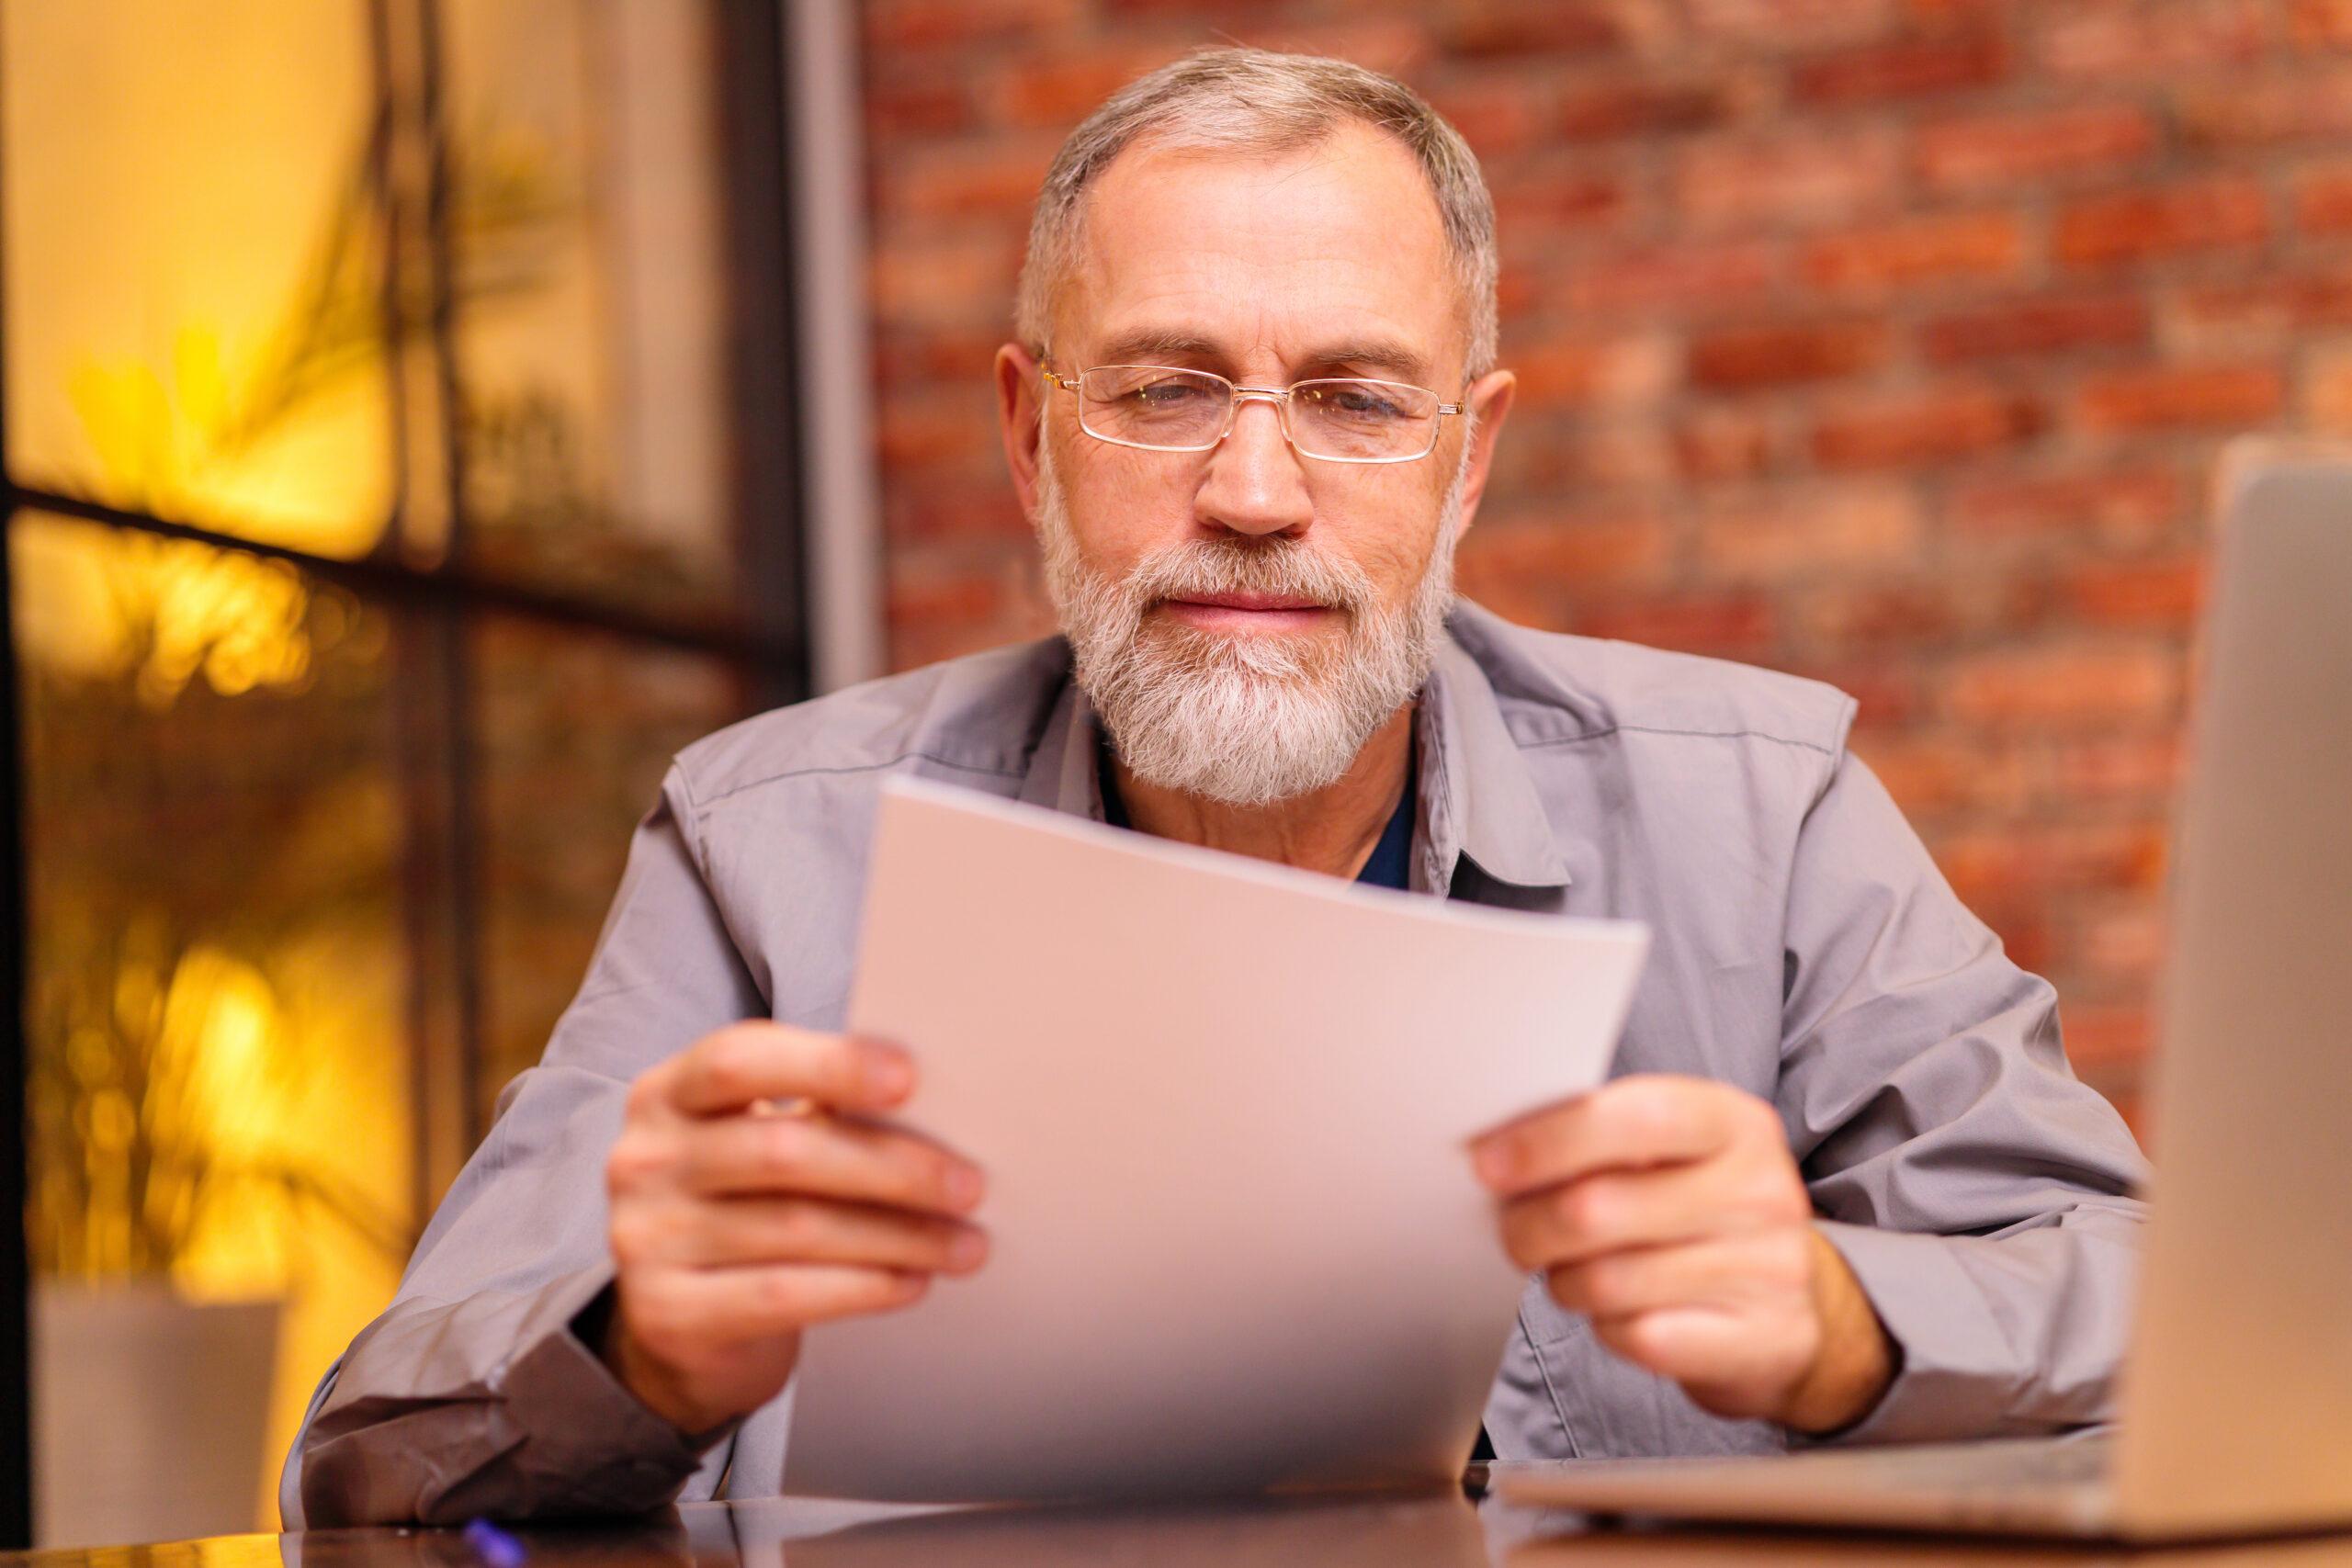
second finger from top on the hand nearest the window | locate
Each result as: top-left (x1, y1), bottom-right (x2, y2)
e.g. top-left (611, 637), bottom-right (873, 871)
top-left (684, 1117), bottom-right (983, 1215)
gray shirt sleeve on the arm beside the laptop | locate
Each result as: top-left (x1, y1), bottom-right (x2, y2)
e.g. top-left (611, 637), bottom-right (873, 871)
top-left (1778, 755), bottom-right (2147, 1441)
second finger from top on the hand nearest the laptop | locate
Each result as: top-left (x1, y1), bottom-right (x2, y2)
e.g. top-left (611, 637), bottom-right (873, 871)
top-left (1503, 1159), bottom-right (1769, 1269)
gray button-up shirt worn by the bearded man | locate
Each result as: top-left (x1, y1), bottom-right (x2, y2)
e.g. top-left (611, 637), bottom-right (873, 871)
top-left (280, 604), bottom-right (2145, 1528)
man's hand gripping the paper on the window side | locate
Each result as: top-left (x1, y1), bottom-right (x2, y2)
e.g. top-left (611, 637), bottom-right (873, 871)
top-left (597, 1021), bottom-right (988, 1434)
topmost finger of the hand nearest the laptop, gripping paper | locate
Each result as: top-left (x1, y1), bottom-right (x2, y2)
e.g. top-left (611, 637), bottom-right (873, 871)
top-left (1470, 1075), bottom-right (1785, 1194)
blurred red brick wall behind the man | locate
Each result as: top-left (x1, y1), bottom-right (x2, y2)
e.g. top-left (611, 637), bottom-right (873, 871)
top-left (864, 0), bottom-right (2352, 1128)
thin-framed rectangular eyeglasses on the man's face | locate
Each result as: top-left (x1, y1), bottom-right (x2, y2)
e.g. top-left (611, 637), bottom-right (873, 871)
top-left (1045, 365), bottom-right (1463, 463)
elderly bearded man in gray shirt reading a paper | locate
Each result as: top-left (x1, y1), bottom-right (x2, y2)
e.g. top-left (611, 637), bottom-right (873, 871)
top-left (285, 50), bottom-right (2143, 1526)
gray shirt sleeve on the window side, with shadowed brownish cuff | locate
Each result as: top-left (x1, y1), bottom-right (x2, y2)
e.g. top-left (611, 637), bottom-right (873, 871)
top-left (280, 769), bottom-right (767, 1530)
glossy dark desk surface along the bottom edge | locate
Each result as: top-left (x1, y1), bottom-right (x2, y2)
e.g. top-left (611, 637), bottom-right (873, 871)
top-left (0, 1493), bottom-right (2352, 1568)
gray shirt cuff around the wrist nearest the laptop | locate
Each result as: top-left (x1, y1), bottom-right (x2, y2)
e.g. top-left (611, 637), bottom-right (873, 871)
top-left (1794, 1220), bottom-right (2023, 1443)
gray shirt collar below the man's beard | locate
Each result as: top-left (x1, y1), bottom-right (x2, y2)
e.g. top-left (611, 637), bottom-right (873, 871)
top-left (1021, 635), bottom-right (1569, 891)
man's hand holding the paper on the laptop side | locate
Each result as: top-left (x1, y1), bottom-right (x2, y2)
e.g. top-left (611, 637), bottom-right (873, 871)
top-left (1473, 1077), bottom-right (1894, 1432)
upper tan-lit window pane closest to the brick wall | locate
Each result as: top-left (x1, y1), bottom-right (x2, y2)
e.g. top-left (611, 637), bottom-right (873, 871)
top-left (445, 0), bottom-right (736, 614)
